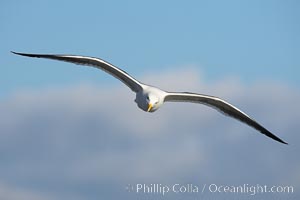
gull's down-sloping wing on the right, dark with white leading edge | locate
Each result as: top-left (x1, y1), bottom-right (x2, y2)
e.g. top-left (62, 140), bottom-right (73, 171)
top-left (164, 93), bottom-right (287, 144)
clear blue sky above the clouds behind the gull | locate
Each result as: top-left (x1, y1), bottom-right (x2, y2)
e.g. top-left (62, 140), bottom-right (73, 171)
top-left (0, 0), bottom-right (300, 96)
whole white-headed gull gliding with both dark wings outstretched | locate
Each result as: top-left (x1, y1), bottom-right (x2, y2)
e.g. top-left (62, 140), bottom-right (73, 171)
top-left (12, 51), bottom-right (287, 144)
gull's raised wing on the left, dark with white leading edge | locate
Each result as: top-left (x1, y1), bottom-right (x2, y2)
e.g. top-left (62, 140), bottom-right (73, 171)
top-left (12, 51), bottom-right (142, 92)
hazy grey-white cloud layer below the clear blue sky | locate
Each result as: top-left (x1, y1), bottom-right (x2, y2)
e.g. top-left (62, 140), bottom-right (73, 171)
top-left (0, 67), bottom-right (300, 200)
